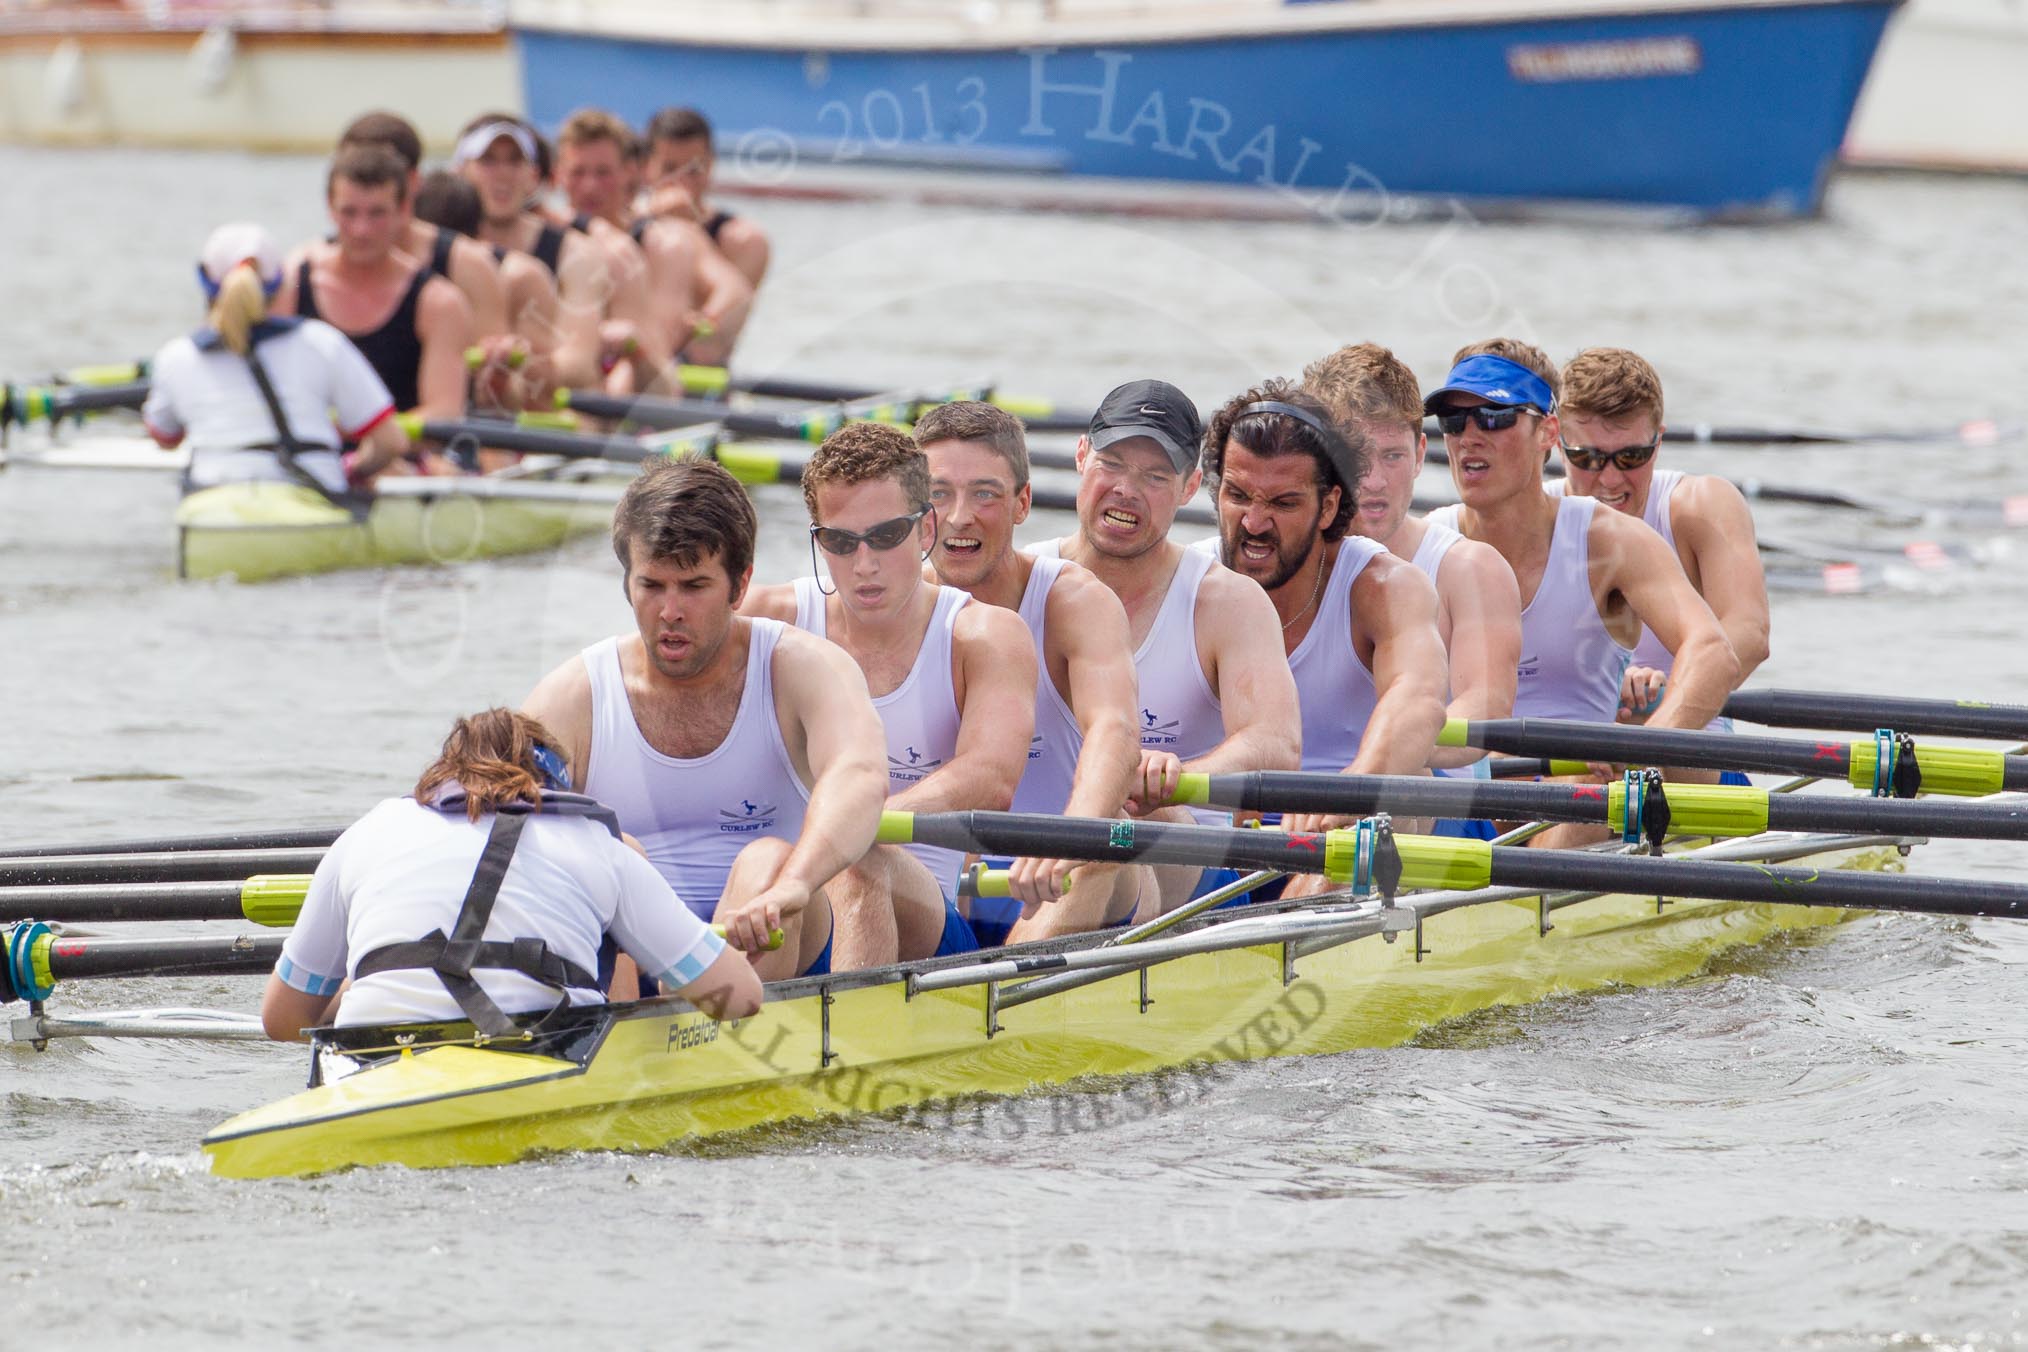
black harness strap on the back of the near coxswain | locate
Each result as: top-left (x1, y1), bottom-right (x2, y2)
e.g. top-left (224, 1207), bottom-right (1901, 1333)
top-left (353, 793), bottom-right (621, 1038)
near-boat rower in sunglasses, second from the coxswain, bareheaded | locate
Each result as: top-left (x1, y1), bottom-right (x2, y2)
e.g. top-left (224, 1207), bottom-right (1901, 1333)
top-left (742, 422), bottom-right (1034, 959)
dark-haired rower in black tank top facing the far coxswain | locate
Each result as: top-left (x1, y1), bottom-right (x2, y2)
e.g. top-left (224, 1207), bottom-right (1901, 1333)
top-left (274, 146), bottom-right (473, 420)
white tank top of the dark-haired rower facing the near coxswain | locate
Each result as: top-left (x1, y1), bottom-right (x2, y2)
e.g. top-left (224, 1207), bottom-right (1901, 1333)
top-left (582, 620), bottom-right (809, 920)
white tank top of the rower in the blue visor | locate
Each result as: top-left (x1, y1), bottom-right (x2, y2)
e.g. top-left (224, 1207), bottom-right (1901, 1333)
top-left (1428, 497), bottom-right (1635, 724)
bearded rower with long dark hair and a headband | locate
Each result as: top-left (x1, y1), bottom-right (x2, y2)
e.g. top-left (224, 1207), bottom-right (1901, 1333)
top-left (1205, 381), bottom-right (1448, 867)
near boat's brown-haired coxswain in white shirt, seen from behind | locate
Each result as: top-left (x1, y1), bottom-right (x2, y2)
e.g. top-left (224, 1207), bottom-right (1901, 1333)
top-left (262, 709), bottom-right (761, 1040)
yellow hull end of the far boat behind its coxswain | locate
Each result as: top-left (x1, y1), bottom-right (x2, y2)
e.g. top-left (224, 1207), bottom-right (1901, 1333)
top-left (176, 478), bottom-right (610, 582)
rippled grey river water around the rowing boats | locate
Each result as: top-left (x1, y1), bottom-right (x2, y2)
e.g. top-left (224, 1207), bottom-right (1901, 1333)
top-left (0, 150), bottom-right (2028, 1350)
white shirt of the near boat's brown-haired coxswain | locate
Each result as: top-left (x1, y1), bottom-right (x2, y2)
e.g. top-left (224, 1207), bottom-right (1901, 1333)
top-left (274, 799), bottom-right (726, 1024)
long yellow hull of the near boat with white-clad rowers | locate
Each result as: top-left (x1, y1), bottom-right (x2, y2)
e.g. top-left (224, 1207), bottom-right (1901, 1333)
top-left (205, 849), bottom-right (1896, 1178)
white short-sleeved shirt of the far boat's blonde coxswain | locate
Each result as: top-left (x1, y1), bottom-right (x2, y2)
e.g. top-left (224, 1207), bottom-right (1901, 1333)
top-left (140, 320), bottom-right (393, 493)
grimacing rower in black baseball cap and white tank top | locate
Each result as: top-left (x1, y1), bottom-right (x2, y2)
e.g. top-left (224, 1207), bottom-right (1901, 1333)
top-left (1030, 381), bottom-right (1302, 918)
